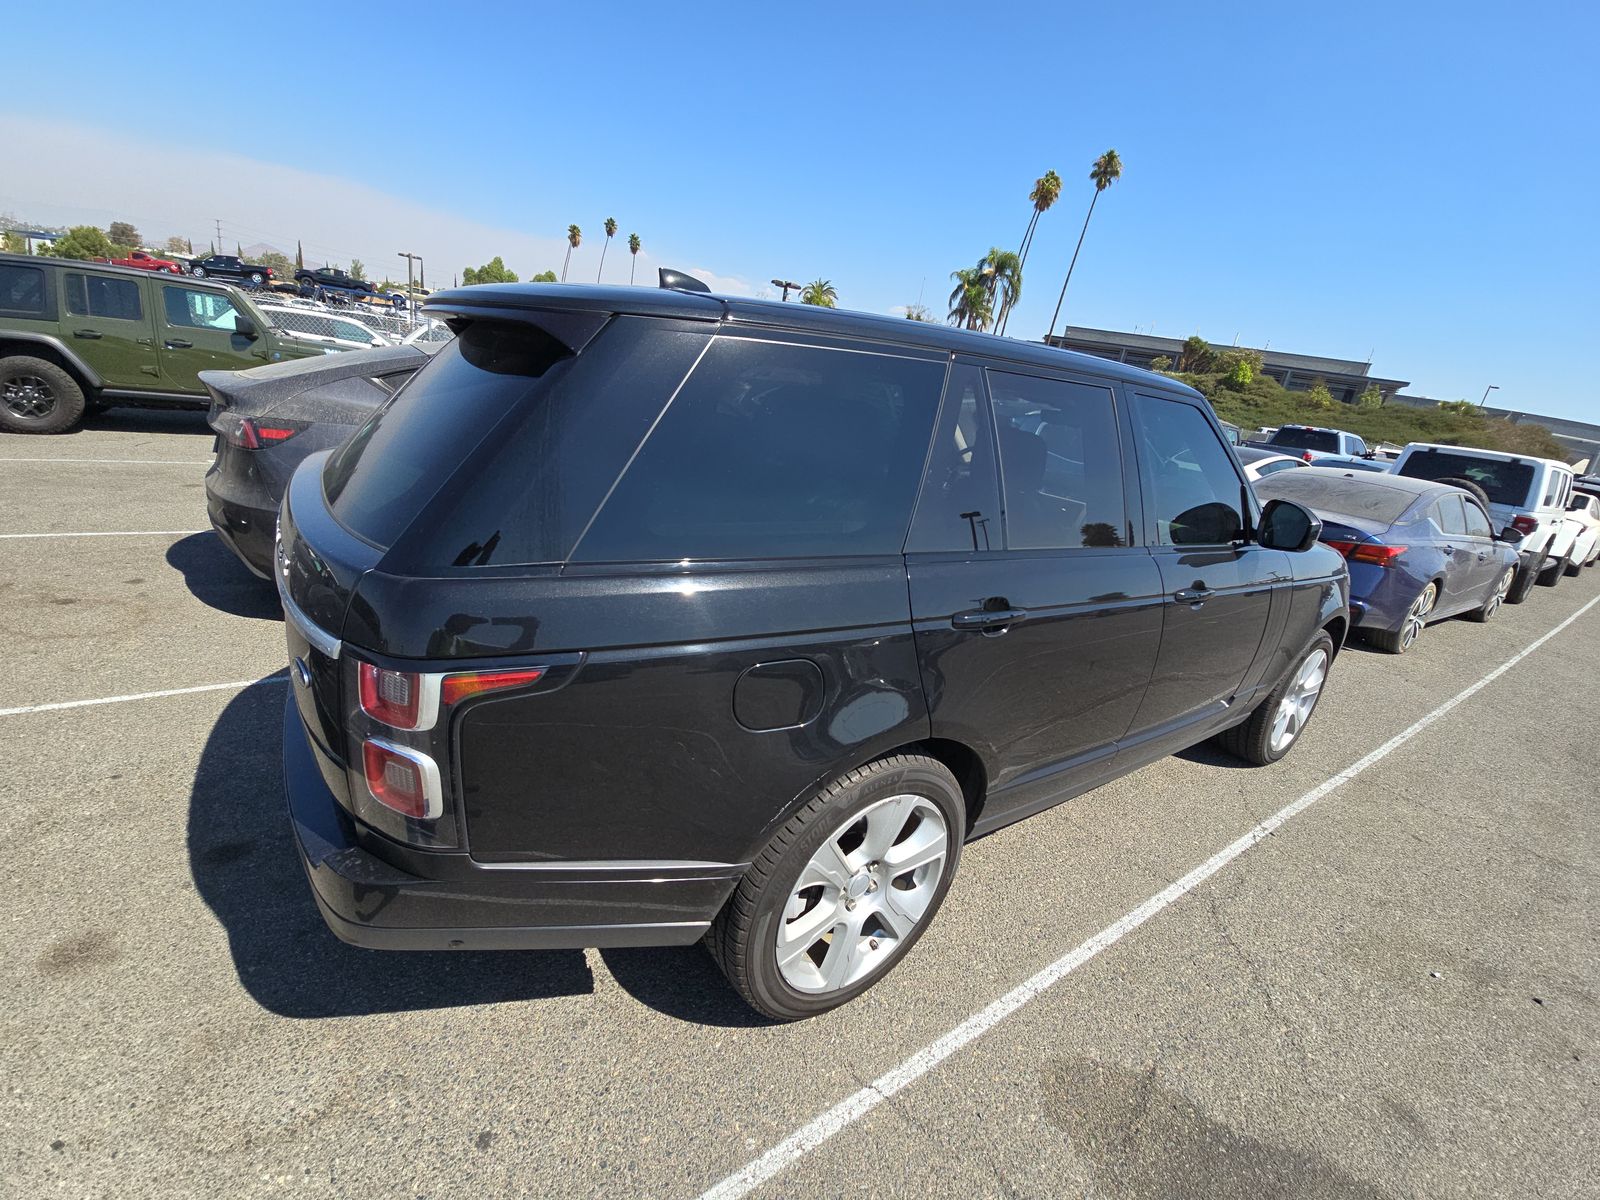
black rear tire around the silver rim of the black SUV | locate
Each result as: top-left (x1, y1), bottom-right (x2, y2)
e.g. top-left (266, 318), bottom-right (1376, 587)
top-left (706, 754), bottom-right (966, 1021)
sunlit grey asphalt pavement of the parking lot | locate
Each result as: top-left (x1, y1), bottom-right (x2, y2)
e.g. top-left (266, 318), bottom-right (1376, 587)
top-left (0, 411), bottom-right (1600, 1200)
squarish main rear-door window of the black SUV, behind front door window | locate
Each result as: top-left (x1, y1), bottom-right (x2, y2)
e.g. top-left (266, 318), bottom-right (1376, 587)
top-left (989, 371), bottom-right (1126, 550)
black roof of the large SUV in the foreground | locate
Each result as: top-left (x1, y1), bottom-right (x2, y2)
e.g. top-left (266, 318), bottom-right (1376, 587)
top-left (422, 283), bottom-right (1203, 398)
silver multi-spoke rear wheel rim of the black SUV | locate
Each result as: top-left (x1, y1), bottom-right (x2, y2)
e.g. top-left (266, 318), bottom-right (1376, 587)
top-left (773, 792), bottom-right (950, 994)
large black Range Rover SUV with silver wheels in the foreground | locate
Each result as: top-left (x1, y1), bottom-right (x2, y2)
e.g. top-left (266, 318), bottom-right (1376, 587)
top-left (277, 276), bottom-right (1349, 1019)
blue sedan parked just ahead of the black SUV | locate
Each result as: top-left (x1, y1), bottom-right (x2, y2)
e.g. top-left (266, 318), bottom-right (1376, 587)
top-left (1256, 467), bottom-right (1520, 654)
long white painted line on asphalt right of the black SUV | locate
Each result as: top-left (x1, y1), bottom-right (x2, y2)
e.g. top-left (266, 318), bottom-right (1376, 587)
top-left (701, 597), bottom-right (1600, 1200)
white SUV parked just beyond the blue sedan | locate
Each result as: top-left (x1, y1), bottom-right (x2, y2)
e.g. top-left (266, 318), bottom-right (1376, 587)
top-left (1392, 442), bottom-right (1584, 605)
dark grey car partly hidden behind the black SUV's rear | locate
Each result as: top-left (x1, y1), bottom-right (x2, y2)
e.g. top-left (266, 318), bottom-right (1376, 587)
top-left (200, 346), bottom-right (438, 579)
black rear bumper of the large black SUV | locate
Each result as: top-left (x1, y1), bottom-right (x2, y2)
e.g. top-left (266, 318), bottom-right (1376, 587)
top-left (283, 696), bottom-right (739, 950)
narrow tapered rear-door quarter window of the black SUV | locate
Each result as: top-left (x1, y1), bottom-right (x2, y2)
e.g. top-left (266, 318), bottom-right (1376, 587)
top-left (906, 363), bottom-right (1002, 550)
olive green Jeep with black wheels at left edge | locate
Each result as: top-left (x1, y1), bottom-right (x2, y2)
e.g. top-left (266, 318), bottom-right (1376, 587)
top-left (0, 254), bottom-right (334, 434)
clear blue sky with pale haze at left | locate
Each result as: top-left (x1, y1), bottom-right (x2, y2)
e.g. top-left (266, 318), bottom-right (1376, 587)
top-left (0, 3), bottom-right (1600, 421)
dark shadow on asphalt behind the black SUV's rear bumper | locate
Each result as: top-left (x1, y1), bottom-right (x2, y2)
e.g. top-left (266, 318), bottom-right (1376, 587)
top-left (189, 681), bottom-right (594, 1018)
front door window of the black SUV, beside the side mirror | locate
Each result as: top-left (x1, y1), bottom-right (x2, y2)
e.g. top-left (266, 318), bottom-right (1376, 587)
top-left (1133, 395), bottom-right (1241, 546)
